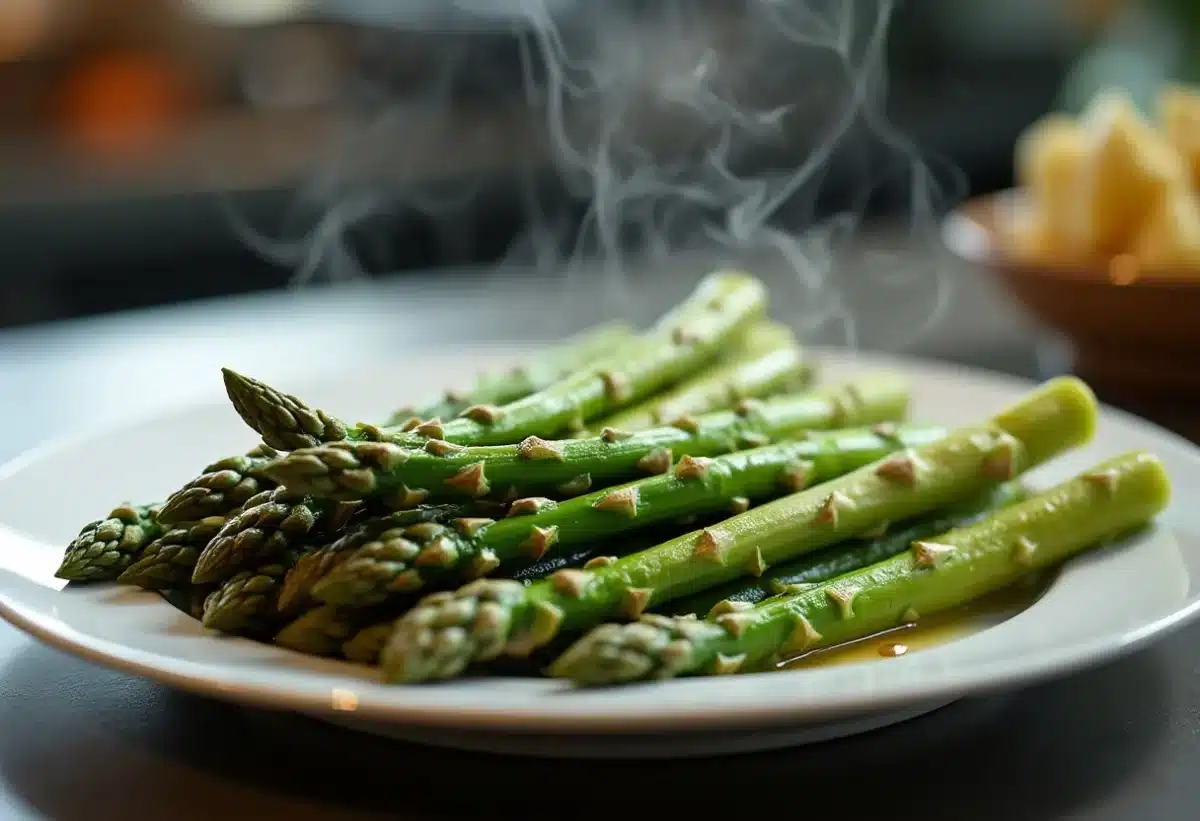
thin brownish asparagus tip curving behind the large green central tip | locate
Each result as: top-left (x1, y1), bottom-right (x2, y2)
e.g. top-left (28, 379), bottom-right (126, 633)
top-left (280, 504), bottom-right (492, 615)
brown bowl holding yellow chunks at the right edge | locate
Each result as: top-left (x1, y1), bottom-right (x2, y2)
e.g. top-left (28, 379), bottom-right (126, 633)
top-left (943, 191), bottom-right (1200, 435)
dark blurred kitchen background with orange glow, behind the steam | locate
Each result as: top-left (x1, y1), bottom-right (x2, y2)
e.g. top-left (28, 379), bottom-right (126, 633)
top-left (0, 0), bottom-right (1200, 326)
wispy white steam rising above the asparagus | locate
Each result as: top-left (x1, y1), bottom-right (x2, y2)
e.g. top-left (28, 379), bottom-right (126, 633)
top-left (223, 0), bottom-right (960, 347)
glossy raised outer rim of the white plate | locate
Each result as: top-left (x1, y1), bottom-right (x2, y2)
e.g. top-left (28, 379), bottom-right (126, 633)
top-left (0, 346), bottom-right (1200, 735)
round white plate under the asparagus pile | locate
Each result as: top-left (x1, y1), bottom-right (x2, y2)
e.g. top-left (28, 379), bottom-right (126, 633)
top-left (0, 352), bottom-right (1200, 755)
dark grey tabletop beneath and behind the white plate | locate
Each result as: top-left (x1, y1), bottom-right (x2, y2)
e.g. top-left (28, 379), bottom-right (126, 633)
top-left (0, 258), bottom-right (1200, 821)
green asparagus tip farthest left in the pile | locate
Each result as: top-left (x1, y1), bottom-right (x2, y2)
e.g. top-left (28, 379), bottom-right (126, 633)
top-left (54, 503), bottom-right (163, 582)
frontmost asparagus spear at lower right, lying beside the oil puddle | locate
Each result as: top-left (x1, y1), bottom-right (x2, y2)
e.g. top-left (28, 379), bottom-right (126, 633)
top-left (551, 451), bottom-right (1171, 684)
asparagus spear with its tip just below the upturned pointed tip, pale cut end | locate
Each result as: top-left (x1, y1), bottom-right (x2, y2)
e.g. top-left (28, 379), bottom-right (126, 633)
top-left (260, 373), bottom-right (908, 508)
